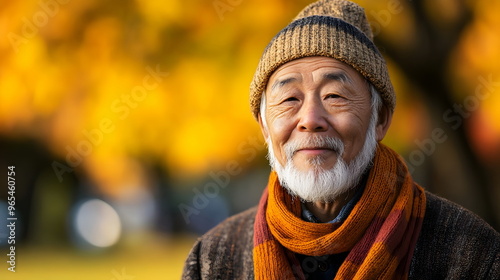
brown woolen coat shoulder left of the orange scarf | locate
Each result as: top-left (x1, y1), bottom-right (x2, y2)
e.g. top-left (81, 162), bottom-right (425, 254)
top-left (182, 207), bottom-right (257, 279)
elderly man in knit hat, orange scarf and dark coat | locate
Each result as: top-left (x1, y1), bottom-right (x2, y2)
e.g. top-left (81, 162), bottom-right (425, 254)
top-left (183, 0), bottom-right (500, 279)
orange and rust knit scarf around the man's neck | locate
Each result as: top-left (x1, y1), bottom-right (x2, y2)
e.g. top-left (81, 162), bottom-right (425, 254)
top-left (253, 144), bottom-right (426, 280)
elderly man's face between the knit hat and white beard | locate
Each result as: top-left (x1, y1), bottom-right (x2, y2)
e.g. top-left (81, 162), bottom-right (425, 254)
top-left (261, 57), bottom-right (379, 172)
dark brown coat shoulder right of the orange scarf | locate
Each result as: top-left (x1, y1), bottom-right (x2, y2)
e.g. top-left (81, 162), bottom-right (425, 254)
top-left (410, 192), bottom-right (500, 279)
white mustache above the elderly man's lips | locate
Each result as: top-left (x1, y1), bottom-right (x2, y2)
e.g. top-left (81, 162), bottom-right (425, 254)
top-left (284, 134), bottom-right (344, 160)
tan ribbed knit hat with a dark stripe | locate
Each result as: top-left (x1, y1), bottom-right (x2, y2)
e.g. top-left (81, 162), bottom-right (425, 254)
top-left (250, 0), bottom-right (396, 118)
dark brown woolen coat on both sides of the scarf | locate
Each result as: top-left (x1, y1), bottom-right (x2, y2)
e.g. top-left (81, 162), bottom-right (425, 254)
top-left (182, 193), bottom-right (500, 280)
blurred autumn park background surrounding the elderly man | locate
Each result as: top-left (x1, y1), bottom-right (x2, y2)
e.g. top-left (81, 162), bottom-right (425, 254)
top-left (0, 0), bottom-right (500, 280)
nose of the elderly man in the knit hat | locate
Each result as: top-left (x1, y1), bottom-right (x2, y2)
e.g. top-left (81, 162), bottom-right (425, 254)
top-left (297, 100), bottom-right (328, 132)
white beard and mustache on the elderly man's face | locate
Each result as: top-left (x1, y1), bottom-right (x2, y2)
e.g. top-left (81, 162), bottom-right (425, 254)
top-left (266, 113), bottom-right (377, 202)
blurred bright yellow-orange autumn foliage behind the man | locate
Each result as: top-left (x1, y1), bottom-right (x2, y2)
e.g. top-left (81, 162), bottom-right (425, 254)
top-left (0, 0), bottom-right (500, 192)
